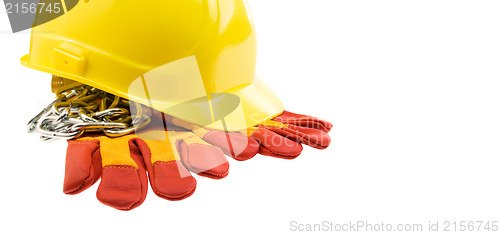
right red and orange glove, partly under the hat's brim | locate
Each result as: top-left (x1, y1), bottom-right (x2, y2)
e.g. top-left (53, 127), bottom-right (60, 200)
top-left (166, 111), bottom-right (332, 161)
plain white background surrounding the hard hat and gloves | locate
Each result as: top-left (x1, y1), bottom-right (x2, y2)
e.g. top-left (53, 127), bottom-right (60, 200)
top-left (0, 0), bottom-right (500, 234)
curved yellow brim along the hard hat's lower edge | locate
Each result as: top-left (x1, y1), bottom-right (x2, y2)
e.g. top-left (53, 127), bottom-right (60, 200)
top-left (21, 55), bottom-right (284, 131)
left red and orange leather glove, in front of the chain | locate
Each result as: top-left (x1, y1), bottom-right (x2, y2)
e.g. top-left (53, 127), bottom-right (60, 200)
top-left (64, 113), bottom-right (258, 210)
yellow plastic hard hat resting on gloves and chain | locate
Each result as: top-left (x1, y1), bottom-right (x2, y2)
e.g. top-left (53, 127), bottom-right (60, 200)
top-left (21, 0), bottom-right (283, 130)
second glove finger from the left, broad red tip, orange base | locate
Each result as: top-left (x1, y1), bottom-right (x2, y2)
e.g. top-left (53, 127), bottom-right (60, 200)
top-left (97, 136), bottom-right (148, 210)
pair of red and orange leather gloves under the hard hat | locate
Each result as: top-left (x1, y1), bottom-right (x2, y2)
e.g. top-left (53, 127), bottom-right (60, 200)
top-left (60, 111), bottom-right (332, 210)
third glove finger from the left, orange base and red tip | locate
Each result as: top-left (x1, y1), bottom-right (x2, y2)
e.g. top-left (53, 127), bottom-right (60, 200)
top-left (138, 131), bottom-right (196, 201)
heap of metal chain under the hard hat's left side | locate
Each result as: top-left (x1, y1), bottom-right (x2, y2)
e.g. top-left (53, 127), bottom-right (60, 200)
top-left (28, 84), bottom-right (151, 140)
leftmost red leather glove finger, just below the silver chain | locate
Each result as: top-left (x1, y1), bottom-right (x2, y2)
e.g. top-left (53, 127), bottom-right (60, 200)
top-left (63, 140), bottom-right (102, 194)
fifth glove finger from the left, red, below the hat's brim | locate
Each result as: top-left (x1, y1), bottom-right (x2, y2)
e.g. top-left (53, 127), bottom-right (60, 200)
top-left (203, 130), bottom-right (259, 161)
